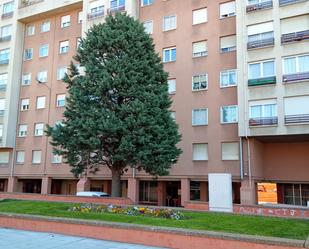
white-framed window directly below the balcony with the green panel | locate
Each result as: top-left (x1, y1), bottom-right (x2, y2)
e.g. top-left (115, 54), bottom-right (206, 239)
top-left (249, 99), bottom-right (277, 119)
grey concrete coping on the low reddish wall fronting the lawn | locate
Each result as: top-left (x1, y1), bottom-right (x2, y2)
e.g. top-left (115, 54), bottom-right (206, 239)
top-left (0, 213), bottom-right (309, 248)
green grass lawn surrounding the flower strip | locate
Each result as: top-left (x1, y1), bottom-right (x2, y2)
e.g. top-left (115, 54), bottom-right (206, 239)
top-left (0, 200), bottom-right (309, 239)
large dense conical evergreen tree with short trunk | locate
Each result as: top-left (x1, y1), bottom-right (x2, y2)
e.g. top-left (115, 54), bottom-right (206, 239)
top-left (47, 13), bottom-right (181, 197)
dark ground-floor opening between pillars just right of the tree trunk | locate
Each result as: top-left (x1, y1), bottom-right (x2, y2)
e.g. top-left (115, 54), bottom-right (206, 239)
top-left (139, 181), bottom-right (158, 204)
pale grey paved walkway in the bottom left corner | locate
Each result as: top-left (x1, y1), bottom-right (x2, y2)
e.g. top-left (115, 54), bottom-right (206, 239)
top-left (0, 228), bottom-right (163, 249)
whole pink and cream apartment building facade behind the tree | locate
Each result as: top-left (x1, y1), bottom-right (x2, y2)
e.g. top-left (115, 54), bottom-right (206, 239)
top-left (0, 0), bottom-right (309, 206)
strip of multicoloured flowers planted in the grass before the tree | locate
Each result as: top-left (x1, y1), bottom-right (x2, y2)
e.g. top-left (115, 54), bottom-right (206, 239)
top-left (69, 204), bottom-right (184, 220)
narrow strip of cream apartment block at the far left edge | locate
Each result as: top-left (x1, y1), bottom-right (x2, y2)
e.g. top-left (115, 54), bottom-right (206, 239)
top-left (0, 0), bottom-right (22, 191)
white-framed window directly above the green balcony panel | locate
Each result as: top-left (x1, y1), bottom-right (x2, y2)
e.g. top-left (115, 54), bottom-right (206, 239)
top-left (249, 60), bottom-right (275, 79)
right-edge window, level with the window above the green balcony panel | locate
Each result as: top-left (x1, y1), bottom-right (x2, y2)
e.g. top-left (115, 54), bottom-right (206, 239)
top-left (283, 55), bottom-right (309, 74)
